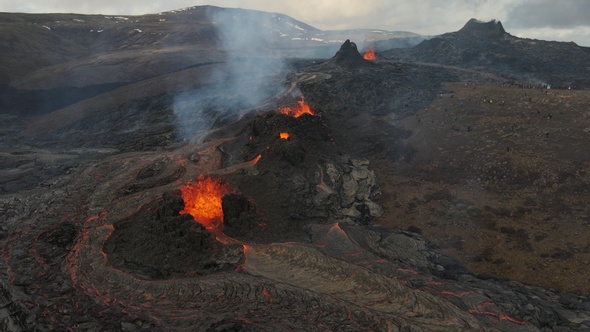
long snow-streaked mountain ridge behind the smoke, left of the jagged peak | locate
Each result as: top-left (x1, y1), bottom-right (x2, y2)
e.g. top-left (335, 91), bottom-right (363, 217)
top-left (0, 6), bottom-right (420, 88)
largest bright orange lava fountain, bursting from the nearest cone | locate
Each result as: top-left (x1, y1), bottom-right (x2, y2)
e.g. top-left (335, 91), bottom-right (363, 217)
top-left (180, 175), bottom-right (231, 231)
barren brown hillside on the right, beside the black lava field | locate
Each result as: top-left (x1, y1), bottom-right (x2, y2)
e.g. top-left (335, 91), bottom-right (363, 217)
top-left (372, 83), bottom-right (590, 294)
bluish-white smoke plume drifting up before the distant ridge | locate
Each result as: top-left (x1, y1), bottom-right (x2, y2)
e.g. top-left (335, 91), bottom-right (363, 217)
top-left (173, 7), bottom-right (289, 143)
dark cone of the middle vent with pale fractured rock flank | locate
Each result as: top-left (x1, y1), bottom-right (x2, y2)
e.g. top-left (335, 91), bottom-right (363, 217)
top-left (250, 111), bottom-right (381, 222)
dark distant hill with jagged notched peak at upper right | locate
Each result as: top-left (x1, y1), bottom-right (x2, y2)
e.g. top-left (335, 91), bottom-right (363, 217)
top-left (385, 19), bottom-right (590, 86)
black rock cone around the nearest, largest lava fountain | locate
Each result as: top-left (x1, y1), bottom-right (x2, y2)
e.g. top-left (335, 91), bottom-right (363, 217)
top-left (104, 194), bottom-right (241, 279)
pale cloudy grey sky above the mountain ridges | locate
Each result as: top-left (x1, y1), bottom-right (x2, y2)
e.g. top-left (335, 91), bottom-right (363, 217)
top-left (0, 0), bottom-right (590, 46)
